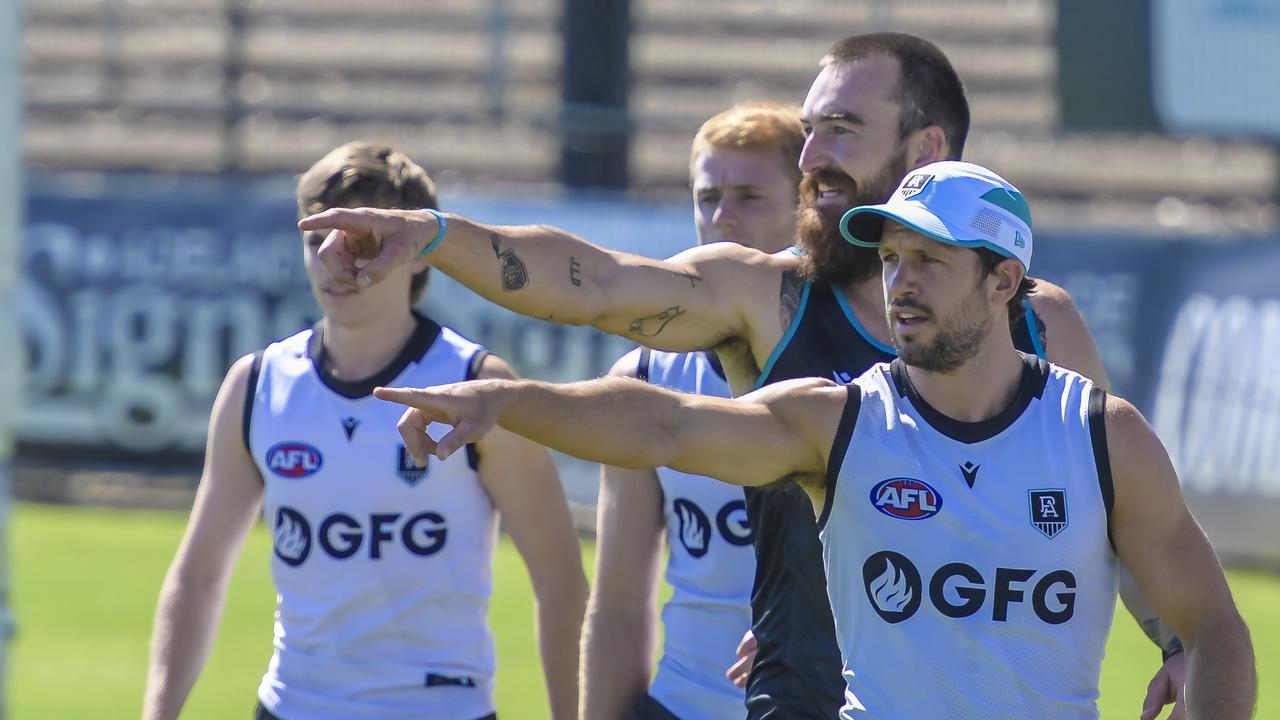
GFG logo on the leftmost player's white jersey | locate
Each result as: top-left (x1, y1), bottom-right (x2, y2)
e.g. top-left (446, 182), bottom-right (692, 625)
top-left (274, 505), bottom-right (448, 568)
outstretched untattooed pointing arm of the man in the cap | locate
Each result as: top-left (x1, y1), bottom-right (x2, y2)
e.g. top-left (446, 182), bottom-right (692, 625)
top-left (374, 378), bottom-right (847, 486)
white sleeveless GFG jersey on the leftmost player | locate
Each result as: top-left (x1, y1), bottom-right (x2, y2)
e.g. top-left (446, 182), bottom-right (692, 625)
top-left (244, 316), bottom-right (497, 720)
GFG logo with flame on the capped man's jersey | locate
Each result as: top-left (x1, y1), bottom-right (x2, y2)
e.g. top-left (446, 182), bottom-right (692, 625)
top-left (863, 550), bottom-right (1075, 625)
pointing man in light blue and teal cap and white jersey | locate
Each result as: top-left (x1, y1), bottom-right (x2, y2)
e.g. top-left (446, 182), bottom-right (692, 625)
top-left (376, 161), bottom-right (1256, 719)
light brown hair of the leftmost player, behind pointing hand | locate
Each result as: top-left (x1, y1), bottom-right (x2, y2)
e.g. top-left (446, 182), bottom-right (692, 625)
top-left (296, 141), bottom-right (439, 305)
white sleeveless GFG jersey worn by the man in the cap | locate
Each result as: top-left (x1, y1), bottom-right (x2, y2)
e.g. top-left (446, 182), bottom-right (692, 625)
top-left (819, 355), bottom-right (1116, 720)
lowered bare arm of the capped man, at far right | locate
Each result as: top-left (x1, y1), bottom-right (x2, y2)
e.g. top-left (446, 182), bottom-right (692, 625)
top-left (1106, 397), bottom-right (1257, 719)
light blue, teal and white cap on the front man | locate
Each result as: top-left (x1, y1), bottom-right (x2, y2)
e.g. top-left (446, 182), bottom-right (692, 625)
top-left (840, 160), bottom-right (1032, 270)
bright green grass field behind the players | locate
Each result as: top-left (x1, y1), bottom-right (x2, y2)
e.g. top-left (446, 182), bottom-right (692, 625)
top-left (8, 505), bottom-right (1280, 720)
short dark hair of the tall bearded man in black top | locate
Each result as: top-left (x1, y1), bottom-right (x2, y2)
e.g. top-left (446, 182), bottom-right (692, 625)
top-left (822, 32), bottom-right (969, 160)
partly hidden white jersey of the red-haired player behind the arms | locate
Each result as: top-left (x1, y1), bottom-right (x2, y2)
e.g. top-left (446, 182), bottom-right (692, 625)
top-left (636, 351), bottom-right (755, 720)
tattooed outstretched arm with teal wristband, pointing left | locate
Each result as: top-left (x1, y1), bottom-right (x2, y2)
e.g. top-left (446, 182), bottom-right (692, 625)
top-left (298, 208), bottom-right (781, 351)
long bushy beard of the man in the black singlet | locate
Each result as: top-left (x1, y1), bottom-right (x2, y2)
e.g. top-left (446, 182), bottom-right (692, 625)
top-left (796, 152), bottom-right (906, 287)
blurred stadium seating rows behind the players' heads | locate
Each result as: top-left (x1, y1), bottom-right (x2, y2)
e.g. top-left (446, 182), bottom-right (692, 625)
top-left (26, 0), bottom-right (1280, 233)
